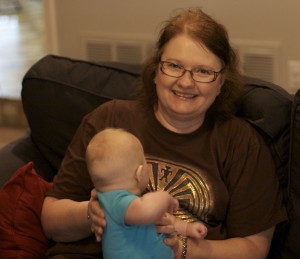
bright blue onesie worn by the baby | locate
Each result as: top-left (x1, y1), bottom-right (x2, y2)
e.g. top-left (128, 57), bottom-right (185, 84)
top-left (97, 190), bottom-right (174, 259)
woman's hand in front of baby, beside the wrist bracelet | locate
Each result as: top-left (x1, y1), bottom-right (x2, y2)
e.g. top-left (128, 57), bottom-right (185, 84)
top-left (156, 213), bottom-right (180, 258)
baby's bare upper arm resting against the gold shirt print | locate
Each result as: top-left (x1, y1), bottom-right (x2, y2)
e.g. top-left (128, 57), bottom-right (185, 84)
top-left (125, 191), bottom-right (178, 225)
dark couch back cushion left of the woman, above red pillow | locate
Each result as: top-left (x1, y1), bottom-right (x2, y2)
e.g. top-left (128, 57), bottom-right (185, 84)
top-left (22, 55), bottom-right (141, 175)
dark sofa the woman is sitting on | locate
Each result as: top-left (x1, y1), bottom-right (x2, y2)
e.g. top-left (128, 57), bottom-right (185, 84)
top-left (0, 55), bottom-right (300, 258)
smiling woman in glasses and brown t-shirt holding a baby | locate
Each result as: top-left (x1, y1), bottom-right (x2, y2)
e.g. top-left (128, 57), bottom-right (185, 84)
top-left (42, 8), bottom-right (286, 259)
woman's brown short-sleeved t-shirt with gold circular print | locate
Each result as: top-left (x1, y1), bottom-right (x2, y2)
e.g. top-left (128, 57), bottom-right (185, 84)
top-left (48, 100), bottom-right (286, 258)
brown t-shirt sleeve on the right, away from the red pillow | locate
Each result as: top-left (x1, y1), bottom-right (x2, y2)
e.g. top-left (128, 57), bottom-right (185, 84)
top-left (224, 126), bottom-right (287, 238)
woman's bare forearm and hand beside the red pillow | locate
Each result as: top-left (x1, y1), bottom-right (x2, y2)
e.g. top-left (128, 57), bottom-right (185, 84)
top-left (41, 189), bottom-right (106, 242)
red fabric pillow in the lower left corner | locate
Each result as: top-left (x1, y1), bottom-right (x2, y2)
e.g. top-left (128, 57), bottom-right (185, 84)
top-left (0, 162), bottom-right (52, 258)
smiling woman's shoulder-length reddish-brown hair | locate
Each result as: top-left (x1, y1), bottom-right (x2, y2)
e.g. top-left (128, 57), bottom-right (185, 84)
top-left (140, 8), bottom-right (241, 121)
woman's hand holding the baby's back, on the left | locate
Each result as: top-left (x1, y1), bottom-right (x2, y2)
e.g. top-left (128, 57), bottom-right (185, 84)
top-left (88, 189), bottom-right (106, 242)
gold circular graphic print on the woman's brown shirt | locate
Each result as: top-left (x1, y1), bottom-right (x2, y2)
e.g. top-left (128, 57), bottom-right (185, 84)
top-left (147, 157), bottom-right (213, 222)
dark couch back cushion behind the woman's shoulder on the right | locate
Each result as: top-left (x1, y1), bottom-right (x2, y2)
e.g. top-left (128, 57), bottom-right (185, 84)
top-left (238, 77), bottom-right (293, 192)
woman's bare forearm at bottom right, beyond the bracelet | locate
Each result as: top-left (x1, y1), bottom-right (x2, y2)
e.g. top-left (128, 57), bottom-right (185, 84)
top-left (186, 227), bottom-right (274, 259)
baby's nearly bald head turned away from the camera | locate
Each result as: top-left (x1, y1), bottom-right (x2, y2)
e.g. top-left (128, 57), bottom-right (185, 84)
top-left (86, 128), bottom-right (149, 195)
